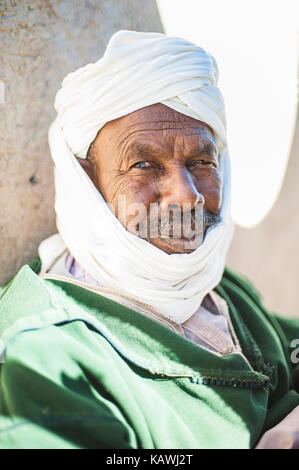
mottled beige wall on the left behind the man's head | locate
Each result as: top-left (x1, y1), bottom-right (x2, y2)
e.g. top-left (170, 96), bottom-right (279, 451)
top-left (0, 0), bottom-right (162, 285)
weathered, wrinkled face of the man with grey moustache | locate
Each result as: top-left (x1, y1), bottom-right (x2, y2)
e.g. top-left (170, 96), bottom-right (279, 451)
top-left (80, 104), bottom-right (222, 254)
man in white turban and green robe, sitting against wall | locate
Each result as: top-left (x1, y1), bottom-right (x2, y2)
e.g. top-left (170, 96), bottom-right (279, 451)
top-left (0, 31), bottom-right (299, 449)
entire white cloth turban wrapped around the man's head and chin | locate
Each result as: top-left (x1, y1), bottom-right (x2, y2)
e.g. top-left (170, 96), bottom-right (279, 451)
top-left (42, 31), bottom-right (233, 323)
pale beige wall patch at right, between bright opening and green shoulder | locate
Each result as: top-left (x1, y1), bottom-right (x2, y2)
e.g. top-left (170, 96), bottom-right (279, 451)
top-left (227, 107), bottom-right (299, 318)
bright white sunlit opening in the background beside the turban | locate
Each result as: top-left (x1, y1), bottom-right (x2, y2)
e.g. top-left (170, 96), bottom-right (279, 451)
top-left (157, 0), bottom-right (299, 227)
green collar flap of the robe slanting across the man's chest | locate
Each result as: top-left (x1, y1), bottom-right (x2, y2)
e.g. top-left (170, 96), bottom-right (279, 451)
top-left (0, 265), bottom-right (268, 388)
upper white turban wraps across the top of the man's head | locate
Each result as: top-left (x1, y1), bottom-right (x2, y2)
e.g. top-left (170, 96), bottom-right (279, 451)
top-left (55, 31), bottom-right (225, 158)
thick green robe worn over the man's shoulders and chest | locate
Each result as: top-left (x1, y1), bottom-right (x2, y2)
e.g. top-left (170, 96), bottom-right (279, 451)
top-left (0, 262), bottom-right (299, 449)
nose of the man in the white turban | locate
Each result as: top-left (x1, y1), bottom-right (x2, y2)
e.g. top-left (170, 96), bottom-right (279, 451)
top-left (160, 167), bottom-right (205, 210)
